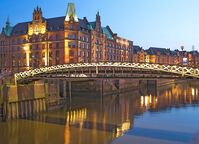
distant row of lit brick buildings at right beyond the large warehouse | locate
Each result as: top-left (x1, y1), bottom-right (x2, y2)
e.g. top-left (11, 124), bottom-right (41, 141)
top-left (132, 45), bottom-right (199, 67)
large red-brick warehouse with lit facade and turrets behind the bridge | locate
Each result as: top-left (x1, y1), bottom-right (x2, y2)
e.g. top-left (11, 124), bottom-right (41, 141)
top-left (0, 3), bottom-right (133, 72)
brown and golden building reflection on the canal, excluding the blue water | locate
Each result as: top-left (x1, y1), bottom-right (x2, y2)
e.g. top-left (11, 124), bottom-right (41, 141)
top-left (0, 82), bottom-right (199, 144)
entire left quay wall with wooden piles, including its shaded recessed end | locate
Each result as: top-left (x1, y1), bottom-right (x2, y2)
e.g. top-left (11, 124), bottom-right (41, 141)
top-left (0, 81), bottom-right (62, 120)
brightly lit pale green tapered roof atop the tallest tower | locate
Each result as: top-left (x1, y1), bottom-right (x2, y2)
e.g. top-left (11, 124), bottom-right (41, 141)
top-left (65, 3), bottom-right (78, 22)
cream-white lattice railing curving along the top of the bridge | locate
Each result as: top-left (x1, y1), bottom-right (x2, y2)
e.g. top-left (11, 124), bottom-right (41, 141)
top-left (15, 62), bottom-right (199, 81)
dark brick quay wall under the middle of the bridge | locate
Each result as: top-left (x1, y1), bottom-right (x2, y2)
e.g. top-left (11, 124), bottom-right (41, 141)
top-left (71, 79), bottom-right (156, 95)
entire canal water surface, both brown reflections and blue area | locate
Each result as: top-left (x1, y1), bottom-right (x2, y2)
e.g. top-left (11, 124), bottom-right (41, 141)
top-left (0, 82), bottom-right (199, 144)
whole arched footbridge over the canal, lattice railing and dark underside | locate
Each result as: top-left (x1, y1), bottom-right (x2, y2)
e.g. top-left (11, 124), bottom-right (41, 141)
top-left (15, 62), bottom-right (199, 81)
